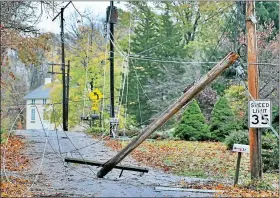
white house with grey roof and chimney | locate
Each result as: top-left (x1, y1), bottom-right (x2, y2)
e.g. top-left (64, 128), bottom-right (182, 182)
top-left (24, 78), bottom-right (54, 130)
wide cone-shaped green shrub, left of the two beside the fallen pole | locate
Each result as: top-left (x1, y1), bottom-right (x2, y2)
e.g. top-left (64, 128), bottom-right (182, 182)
top-left (174, 100), bottom-right (210, 141)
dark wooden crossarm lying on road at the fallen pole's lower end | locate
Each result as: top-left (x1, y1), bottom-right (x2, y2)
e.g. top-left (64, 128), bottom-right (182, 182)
top-left (64, 157), bottom-right (149, 178)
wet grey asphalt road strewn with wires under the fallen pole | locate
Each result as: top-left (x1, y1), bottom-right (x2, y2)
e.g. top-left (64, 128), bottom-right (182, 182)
top-left (16, 130), bottom-right (213, 197)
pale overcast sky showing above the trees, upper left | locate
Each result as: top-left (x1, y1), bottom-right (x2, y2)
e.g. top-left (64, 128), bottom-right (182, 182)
top-left (38, 1), bottom-right (125, 33)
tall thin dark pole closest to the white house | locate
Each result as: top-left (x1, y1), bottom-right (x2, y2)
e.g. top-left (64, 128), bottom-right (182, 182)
top-left (60, 8), bottom-right (68, 131)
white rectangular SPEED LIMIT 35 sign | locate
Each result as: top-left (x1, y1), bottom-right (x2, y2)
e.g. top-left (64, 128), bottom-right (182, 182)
top-left (249, 100), bottom-right (271, 128)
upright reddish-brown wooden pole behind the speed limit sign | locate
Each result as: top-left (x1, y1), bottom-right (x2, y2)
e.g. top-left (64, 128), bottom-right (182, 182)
top-left (246, 0), bottom-right (262, 179)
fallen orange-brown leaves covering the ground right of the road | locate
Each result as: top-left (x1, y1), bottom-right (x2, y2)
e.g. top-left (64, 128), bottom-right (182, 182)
top-left (106, 140), bottom-right (279, 197)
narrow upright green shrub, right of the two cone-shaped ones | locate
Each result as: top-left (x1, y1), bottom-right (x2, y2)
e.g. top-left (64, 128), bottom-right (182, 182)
top-left (210, 97), bottom-right (239, 141)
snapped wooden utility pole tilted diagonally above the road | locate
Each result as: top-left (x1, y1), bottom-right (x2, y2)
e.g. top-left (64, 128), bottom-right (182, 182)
top-left (97, 52), bottom-right (239, 178)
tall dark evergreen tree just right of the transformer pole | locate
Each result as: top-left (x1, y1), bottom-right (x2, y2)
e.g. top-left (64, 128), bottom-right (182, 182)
top-left (128, 2), bottom-right (161, 123)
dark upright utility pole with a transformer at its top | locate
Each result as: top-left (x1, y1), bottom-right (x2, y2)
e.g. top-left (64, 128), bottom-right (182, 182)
top-left (107, 1), bottom-right (118, 136)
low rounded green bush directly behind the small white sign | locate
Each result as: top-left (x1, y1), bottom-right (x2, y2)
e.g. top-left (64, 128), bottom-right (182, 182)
top-left (224, 130), bottom-right (249, 150)
